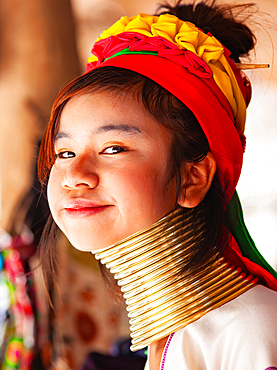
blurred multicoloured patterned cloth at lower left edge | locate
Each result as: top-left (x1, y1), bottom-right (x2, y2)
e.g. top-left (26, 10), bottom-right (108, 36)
top-left (0, 232), bottom-right (35, 370)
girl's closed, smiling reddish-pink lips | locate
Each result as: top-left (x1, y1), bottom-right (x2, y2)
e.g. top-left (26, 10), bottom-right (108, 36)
top-left (64, 199), bottom-right (109, 218)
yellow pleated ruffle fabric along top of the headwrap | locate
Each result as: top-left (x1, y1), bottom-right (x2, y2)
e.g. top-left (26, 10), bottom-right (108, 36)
top-left (88, 13), bottom-right (246, 132)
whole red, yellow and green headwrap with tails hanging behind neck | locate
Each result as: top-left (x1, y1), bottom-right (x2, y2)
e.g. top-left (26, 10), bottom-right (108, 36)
top-left (86, 14), bottom-right (277, 290)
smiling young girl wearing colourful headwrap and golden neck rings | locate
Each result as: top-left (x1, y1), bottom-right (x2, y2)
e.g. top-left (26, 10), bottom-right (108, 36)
top-left (39, 2), bottom-right (277, 370)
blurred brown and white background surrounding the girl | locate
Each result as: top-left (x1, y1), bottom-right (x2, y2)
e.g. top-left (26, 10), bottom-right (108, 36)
top-left (0, 0), bottom-right (277, 370)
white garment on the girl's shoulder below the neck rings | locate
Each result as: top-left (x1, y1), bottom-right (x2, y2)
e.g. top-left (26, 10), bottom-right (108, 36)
top-left (145, 285), bottom-right (277, 370)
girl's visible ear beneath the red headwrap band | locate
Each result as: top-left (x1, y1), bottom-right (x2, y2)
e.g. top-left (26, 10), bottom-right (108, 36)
top-left (178, 152), bottom-right (216, 208)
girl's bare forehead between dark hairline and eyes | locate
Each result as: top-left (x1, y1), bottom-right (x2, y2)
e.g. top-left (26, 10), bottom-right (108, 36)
top-left (56, 92), bottom-right (167, 138)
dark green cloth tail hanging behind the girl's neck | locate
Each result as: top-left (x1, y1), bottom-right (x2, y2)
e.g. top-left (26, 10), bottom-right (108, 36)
top-left (228, 191), bottom-right (277, 279)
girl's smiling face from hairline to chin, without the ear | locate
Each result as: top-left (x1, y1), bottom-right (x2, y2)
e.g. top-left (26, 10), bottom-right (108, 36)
top-left (48, 92), bottom-right (176, 251)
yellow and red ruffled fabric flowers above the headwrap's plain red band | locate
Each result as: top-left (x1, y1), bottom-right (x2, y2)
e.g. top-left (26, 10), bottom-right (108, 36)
top-left (87, 13), bottom-right (246, 132)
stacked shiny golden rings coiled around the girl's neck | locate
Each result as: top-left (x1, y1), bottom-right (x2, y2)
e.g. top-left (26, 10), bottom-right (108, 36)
top-left (92, 208), bottom-right (256, 351)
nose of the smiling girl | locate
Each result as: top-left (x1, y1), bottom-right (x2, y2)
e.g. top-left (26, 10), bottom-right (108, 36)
top-left (62, 158), bottom-right (99, 189)
